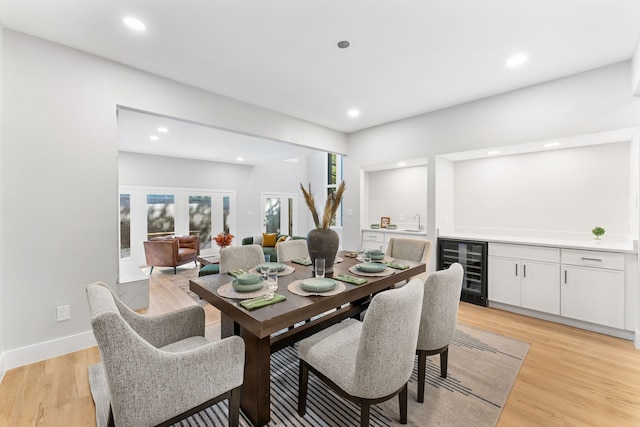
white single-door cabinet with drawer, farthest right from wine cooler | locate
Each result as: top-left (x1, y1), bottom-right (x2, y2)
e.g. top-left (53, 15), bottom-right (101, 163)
top-left (561, 249), bottom-right (625, 329)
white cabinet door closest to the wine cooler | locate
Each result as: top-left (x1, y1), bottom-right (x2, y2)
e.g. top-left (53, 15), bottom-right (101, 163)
top-left (488, 256), bottom-right (521, 306)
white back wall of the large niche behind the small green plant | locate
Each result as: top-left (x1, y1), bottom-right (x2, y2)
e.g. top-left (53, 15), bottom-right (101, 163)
top-left (454, 142), bottom-right (637, 239)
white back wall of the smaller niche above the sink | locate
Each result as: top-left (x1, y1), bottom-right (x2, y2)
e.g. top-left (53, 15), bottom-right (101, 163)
top-left (363, 166), bottom-right (428, 228)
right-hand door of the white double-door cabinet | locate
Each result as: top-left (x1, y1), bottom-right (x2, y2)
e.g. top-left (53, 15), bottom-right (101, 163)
top-left (522, 260), bottom-right (560, 315)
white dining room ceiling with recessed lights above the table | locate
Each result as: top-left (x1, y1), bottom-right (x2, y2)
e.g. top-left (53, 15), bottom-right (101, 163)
top-left (0, 0), bottom-right (640, 132)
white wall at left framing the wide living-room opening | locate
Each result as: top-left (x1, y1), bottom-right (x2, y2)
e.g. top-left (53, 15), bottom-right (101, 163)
top-left (2, 30), bottom-right (346, 367)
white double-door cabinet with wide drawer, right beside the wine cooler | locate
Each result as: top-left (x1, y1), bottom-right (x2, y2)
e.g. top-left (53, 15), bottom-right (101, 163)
top-left (488, 243), bottom-right (560, 314)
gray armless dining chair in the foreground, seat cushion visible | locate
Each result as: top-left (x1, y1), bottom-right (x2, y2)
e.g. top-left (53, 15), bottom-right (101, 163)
top-left (298, 279), bottom-right (424, 426)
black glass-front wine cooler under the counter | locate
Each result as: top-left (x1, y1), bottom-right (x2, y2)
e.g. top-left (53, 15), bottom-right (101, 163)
top-left (437, 238), bottom-right (489, 307)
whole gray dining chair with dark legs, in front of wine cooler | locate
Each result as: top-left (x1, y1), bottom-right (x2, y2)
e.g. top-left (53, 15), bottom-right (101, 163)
top-left (416, 262), bottom-right (464, 403)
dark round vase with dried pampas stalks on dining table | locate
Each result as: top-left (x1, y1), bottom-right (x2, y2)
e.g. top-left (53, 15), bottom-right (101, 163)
top-left (300, 181), bottom-right (346, 276)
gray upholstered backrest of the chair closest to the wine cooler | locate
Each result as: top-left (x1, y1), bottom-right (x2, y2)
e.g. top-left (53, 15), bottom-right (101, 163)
top-left (417, 262), bottom-right (464, 350)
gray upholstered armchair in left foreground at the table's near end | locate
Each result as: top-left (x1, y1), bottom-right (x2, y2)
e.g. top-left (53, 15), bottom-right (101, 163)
top-left (86, 282), bottom-right (244, 427)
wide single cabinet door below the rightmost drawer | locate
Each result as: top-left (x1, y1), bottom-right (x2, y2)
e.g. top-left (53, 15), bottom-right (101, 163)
top-left (561, 266), bottom-right (624, 329)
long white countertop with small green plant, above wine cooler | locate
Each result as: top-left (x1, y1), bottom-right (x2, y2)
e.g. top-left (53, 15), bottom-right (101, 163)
top-left (438, 233), bottom-right (638, 253)
